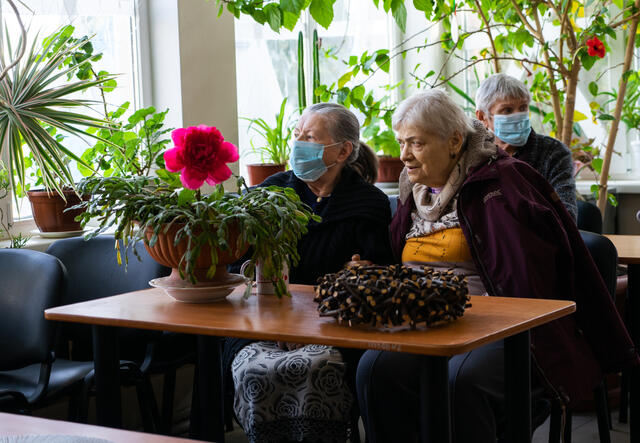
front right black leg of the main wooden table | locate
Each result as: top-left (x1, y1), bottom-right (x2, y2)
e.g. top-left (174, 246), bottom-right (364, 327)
top-left (420, 355), bottom-right (451, 443)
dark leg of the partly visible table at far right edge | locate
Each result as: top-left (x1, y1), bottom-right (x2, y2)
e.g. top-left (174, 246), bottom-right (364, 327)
top-left (626, 264), bottom-right (640, 443)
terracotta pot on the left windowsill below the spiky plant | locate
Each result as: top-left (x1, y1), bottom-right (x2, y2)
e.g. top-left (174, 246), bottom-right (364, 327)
top-left (27, 189), bottom-right (90, 232)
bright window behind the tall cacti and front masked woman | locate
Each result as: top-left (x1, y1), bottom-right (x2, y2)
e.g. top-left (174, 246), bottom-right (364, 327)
top-left (235, 0), bottom-right (391, 173)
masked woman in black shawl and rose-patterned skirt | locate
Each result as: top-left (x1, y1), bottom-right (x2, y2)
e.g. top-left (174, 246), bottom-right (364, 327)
top-left (224, 103), bottom-right (392, 442)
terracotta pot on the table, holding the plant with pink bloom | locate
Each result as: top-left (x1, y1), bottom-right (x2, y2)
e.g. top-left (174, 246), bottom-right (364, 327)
top-left (145, 224), bottom-right (249, 286)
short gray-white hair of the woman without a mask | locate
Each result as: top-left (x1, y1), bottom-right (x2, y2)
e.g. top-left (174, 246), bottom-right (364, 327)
top-left (392, 89), bottom-right (475, 139)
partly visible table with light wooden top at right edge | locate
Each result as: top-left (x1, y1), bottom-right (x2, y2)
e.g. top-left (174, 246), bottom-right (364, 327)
top-left (606, 235), bottom-right (640, 443)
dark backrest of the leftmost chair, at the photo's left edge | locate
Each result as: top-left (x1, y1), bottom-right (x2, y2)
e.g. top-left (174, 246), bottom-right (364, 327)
top-left (0, 249), bottom-right (65, 371)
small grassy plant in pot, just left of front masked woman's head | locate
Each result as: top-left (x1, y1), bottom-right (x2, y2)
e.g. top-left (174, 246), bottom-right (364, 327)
top-left (245, 97), bottom-right (292, 186)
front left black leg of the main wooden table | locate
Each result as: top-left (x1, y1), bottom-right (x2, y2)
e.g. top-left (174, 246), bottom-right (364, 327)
top-left (92, 326), bottom-right (122, 428)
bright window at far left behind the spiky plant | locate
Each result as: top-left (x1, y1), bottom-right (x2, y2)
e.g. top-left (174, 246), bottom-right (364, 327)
top-left (0, 0), bottom-right (140, 225)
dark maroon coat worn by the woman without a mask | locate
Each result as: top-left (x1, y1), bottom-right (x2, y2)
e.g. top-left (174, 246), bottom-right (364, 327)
top-left (391, 151), bottom-right (640, 401)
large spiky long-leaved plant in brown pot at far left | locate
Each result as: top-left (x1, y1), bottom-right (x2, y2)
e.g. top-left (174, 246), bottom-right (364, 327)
top-left (0, 23), bottom-right (111, 231)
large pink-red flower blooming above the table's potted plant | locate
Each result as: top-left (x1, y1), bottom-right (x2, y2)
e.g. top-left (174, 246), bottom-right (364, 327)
top-left (164, 125), bottom-right (239, 189)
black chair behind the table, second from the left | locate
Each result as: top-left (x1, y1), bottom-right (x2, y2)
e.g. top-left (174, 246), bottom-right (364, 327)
top-left (47, 235), bottom-right (195, 434)
